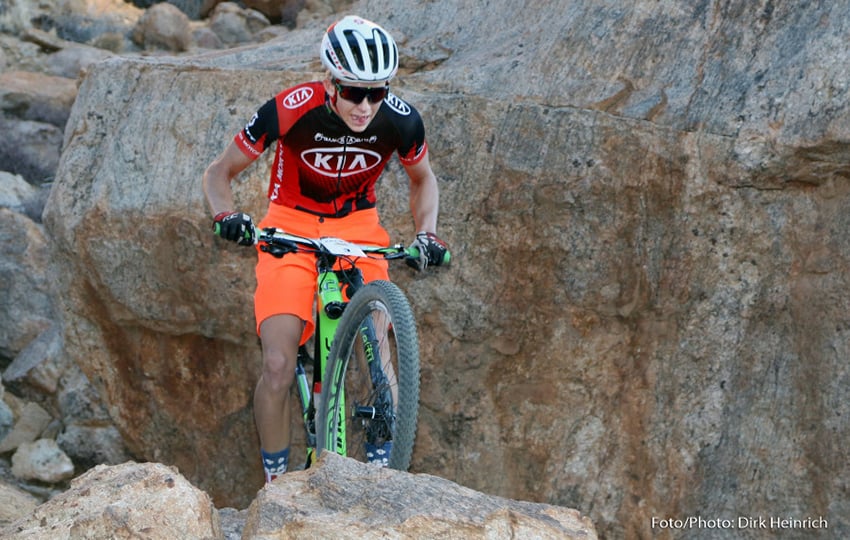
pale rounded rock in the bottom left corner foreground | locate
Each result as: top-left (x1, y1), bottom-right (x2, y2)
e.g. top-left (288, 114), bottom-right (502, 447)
top-left (0, 463), bottom-right (222, 540)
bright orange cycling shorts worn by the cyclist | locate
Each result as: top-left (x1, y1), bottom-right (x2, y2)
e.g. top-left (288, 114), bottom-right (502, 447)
top-left (254, 203), bottom-right (390, 345)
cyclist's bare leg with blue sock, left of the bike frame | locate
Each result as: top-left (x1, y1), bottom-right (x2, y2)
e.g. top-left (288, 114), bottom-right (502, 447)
top-left (254, 315), bottom-right (304, 481)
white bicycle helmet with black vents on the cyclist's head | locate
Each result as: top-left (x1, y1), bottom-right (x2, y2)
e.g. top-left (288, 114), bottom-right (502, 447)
top-left (321, 15), bottom-right (398, 83)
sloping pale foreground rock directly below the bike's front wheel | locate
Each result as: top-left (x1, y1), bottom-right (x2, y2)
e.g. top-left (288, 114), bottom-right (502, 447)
top-left (242, 453), bottom-right (596, 540)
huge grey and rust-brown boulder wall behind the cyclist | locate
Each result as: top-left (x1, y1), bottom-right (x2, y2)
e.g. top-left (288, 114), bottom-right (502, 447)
top-left (45, 0), bottom-right (850, 537)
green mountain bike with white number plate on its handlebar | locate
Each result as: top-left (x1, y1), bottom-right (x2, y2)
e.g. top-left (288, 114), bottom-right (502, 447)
top-left (257, 228), bottom-right (450, 470)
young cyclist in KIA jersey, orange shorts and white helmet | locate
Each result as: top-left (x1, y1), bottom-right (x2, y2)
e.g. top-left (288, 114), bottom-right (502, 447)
top-left (203, 16), bottom-right (446, 482)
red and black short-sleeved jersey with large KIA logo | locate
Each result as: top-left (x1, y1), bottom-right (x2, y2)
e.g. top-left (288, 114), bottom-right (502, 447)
top-left (235, 81), bottom-right (427, 217)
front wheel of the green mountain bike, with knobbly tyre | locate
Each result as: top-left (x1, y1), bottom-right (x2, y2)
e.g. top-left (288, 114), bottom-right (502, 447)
top-left (317, 280), bottom-right (419, 470)
